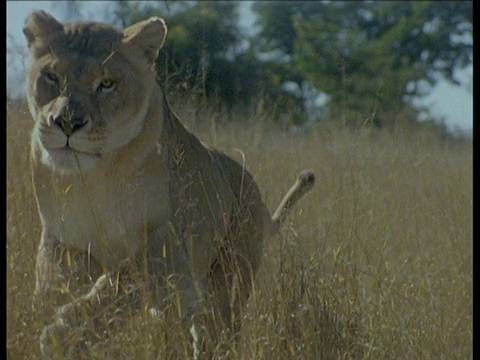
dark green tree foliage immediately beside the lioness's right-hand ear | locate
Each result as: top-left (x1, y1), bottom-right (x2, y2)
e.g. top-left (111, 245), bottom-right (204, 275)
top-left (109, 1), bottom-right (262, 106)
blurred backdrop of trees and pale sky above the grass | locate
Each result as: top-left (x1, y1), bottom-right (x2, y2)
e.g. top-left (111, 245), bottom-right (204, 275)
top-left (7, 1), bottom-right (473, 137)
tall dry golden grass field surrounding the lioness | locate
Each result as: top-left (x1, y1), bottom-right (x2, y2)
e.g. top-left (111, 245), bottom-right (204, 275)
top-left (6, 97), bottom-right (473, 360)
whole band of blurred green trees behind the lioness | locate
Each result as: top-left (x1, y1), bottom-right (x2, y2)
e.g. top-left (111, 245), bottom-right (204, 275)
top-left (109, 1), bottom-right (473, 128)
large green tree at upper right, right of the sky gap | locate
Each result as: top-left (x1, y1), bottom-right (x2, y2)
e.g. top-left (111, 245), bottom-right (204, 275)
top-left (255, 1), bottom-right (472, 125)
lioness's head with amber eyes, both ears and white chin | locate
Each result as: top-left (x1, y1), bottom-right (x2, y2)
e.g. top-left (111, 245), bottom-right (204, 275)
top-left (23, 11), bottom-right (167, 174)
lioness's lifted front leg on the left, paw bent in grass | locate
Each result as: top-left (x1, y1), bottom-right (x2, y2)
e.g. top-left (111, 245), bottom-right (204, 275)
top-left (34, 231), bottom-right (111, 357)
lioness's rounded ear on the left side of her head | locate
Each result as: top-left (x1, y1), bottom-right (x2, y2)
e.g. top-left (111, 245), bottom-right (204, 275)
top-left (23, 11), bottom-right (63, 49)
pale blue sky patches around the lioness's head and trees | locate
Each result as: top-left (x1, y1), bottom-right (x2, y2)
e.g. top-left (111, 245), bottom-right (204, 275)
top-left (7, 1), bottom-right (473, 133)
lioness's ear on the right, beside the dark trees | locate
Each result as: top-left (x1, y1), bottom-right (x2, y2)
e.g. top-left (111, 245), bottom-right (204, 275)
top-left (123, 17), bottom-right (167, 64)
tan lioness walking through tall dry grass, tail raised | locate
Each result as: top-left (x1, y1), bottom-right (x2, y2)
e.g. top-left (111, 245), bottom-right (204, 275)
top-left (23, 11), bottom-right (314, 355)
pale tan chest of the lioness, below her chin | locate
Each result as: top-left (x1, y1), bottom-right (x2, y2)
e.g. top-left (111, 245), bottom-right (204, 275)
top-left (37, 163), bottom-right (170, 267)
